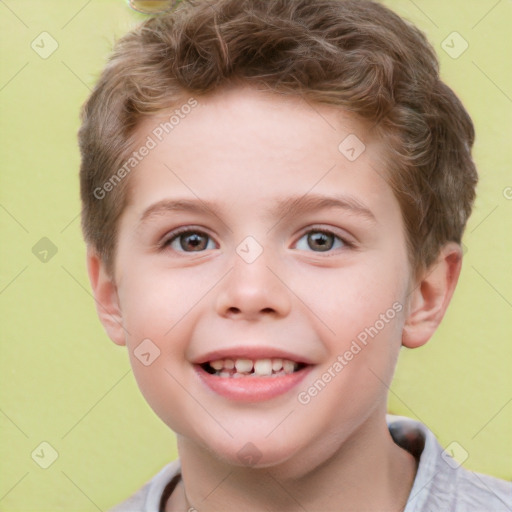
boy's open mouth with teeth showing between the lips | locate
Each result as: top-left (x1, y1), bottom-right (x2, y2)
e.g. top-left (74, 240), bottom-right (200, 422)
top-left (200, 358), bottom-right (308, 379)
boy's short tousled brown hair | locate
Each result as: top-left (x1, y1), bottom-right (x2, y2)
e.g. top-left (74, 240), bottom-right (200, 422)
top-left (79, 0), bottom-right (477, 271)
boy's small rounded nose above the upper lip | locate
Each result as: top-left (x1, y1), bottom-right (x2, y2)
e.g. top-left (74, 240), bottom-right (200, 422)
top-left (216, 254), bottom-right (291, 321)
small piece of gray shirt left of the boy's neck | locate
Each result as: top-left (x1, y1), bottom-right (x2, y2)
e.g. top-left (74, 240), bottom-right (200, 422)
top-left (108, 460), bottom-right (180, 512)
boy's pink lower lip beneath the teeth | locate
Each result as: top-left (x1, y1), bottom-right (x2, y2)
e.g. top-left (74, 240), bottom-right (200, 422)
top-left (196, 365), bottom-right (312, 402)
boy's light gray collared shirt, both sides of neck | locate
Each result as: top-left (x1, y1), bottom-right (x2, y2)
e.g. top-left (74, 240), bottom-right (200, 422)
top-left (110, 415), bottom-right (512, 512)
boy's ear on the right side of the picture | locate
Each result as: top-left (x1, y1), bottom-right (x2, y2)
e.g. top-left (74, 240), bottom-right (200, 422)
top-left (402, 242), bottom-right (462, 348)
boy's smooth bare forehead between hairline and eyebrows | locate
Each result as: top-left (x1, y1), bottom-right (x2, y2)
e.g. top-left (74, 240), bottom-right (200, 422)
top-left (130, 83), bottom-right (393, 218)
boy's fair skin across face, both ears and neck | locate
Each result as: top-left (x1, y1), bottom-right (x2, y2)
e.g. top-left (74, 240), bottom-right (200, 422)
top-left (88, 87), bottom-right (461, 512)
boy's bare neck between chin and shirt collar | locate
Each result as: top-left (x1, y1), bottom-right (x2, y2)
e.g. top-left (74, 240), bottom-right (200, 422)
top-left (166, 418), bottom-right (416, 512)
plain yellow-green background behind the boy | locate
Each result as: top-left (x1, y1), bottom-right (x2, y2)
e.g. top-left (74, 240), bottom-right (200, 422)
top-left (0, 0), bottom-right (512, 511)
